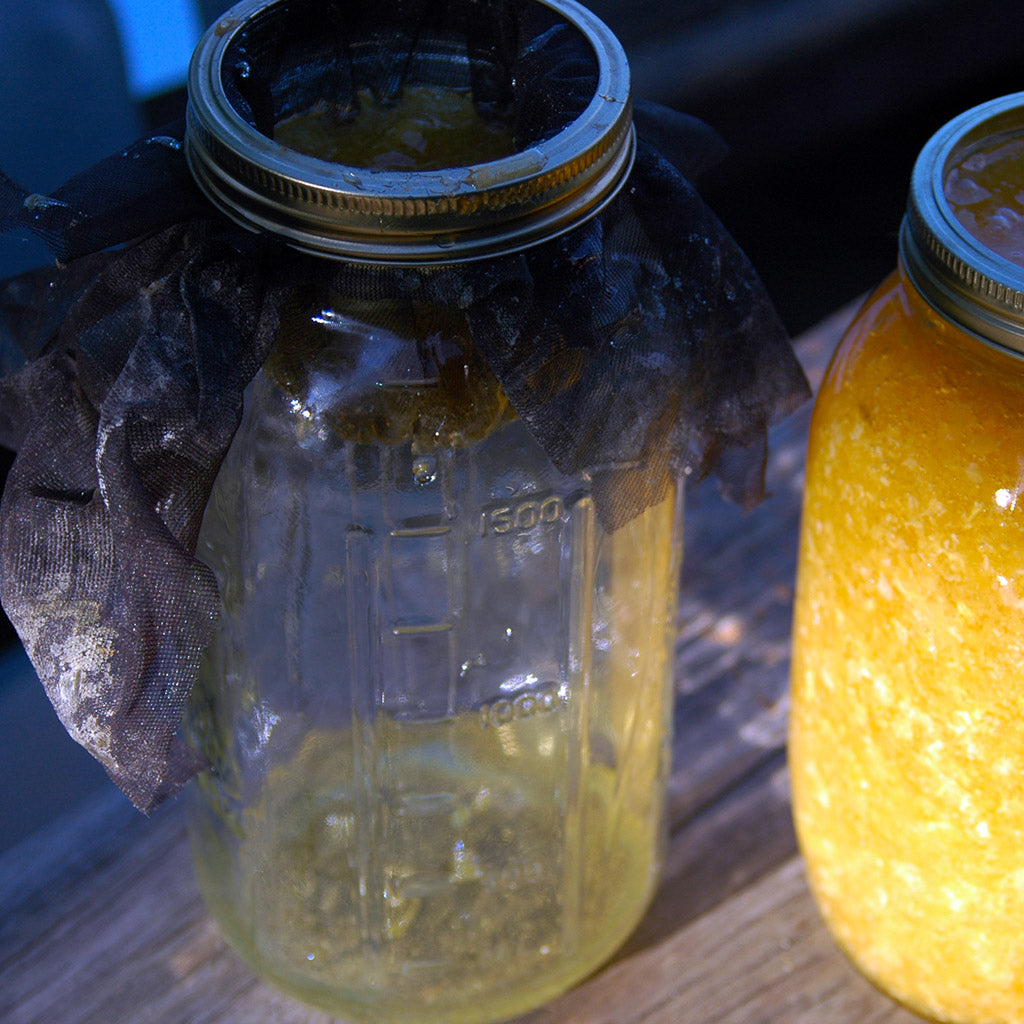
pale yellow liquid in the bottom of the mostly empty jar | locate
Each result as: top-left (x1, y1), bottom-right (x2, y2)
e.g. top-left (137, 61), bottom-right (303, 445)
top-left (193, 702), bottom-right (660, 1024)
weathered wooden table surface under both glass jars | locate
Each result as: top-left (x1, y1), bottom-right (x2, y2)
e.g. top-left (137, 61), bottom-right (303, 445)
top-left (0, 310), bottom-right (921, 1024)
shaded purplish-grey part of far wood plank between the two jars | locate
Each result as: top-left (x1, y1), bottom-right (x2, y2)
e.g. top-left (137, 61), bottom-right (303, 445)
top-left (669, 306), bottom-right (855, 827)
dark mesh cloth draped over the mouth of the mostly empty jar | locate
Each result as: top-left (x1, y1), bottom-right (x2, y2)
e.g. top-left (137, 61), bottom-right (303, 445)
top-left (0, 2), bottom-right (808, 810)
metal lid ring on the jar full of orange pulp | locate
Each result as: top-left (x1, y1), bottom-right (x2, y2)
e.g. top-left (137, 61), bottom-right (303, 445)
top-left (900, 92), bottom-right (1024, 353)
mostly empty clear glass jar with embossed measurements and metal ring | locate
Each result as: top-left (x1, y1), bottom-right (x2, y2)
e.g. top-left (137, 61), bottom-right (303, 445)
top-left (181, 0), bottom-right (682, 1022)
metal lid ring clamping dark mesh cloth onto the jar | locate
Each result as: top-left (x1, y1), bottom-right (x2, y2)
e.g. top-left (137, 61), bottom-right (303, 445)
top-left (185, 0), bottom-right (635, 265)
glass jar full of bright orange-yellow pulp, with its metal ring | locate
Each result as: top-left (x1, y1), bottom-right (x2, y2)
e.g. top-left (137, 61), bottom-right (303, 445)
top-left (790, 93), bottom-right (1024, 1024)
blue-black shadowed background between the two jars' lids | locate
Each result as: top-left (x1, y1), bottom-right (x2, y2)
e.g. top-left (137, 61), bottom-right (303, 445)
top-left (590, 0), bottom-right (1024, 333)
